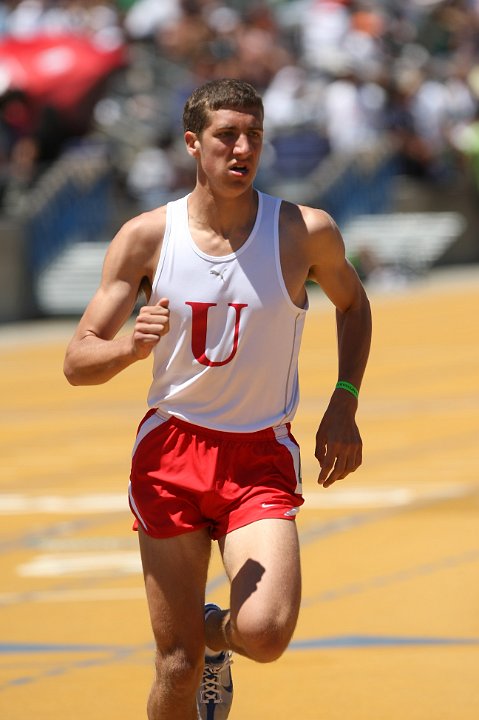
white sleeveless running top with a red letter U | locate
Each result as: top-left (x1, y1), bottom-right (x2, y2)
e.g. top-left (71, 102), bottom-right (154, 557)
top-left (148, 188), bottom-right (306, 432)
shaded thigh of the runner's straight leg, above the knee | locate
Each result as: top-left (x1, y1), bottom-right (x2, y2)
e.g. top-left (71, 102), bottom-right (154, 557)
top-left (139, 529), bottom-right (211, 651)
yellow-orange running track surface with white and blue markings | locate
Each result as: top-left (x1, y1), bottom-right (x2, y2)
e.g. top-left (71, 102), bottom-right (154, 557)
top-left (0, 269), bottom-right (479, 720)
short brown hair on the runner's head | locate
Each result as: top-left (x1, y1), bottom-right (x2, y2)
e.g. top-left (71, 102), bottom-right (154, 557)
top-left (183, 78), bottom-right (264, 135)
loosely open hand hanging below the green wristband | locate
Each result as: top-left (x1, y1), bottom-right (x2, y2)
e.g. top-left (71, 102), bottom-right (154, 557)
top-left (315, 393), bottom-right (363, 488)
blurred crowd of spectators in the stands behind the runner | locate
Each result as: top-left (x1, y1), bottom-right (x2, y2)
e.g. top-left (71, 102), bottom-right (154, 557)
top-left (0, 0), bottom-right (479, 209)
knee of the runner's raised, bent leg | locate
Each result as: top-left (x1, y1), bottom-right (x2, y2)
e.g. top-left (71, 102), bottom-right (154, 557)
top-left (236, 618), bottom-right (295, 663)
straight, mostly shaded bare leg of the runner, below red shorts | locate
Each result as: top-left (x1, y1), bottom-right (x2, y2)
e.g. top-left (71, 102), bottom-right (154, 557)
top-left (139, 530), bottom-right (211, 720)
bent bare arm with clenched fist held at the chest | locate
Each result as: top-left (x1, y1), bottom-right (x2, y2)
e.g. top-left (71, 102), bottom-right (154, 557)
top-left (64, 211), bottom-right (169, 385)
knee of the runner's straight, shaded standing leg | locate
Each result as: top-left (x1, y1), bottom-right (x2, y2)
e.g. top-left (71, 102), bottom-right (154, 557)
top-left (155, 647), bottom-right (203, 696)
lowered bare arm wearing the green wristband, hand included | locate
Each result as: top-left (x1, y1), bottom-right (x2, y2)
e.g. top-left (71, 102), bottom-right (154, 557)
top-left (303, 208), bottom-right (372, 487)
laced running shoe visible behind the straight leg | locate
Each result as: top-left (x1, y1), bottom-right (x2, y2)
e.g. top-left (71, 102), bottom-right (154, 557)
top-left (196, 603), bottom-right (233, 720)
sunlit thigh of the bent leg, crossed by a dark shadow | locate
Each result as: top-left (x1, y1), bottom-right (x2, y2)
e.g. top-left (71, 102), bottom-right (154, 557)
top-left (220, 519), bottom-right (301, 631)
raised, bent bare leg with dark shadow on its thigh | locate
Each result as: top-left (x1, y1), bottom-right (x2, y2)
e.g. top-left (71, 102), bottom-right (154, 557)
top-left (206, 519), bottom-right (301, 662)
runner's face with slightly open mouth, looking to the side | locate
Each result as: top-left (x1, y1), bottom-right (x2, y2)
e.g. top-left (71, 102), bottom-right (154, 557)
top-left (185, 109), bottom-right (263, 190)
